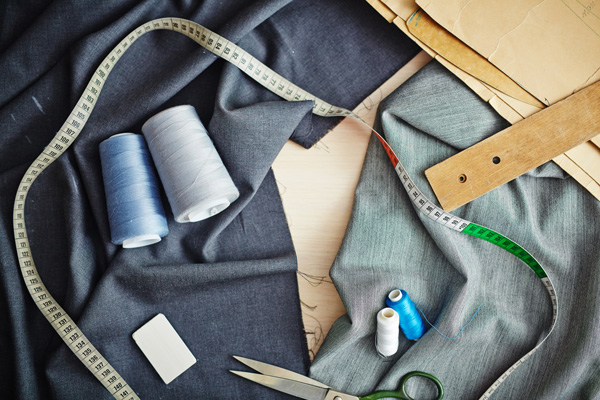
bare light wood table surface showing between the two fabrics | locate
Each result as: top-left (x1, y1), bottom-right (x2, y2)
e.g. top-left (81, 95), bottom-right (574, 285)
top-left (273, 52), bottom-right (431, 359)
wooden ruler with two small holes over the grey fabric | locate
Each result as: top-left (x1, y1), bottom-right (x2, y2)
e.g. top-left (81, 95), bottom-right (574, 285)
top-left (425, 82), bottom-right (600, 211)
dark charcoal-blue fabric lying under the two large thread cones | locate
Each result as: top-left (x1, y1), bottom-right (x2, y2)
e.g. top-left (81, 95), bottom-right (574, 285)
top-left (0, 0), bottom-right (417, 399)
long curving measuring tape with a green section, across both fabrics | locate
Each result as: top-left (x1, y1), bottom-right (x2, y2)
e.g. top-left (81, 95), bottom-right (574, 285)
top-left (13, 18), bottom-right (558, 400)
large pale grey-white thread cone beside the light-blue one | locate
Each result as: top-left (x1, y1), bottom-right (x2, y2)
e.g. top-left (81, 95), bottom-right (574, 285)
top-left (142, 105), bottom-right (240, 223)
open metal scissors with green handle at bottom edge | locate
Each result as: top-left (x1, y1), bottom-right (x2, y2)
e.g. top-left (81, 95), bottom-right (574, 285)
top-left (229, 356), bottom-right (444, 400)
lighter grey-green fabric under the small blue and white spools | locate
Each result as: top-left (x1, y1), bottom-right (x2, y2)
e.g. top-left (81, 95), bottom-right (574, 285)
top-left (310, 62), bottom-right (600, 399)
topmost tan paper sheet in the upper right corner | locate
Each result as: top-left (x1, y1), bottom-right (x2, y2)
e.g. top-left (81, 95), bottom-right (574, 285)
top-left (417, 0), bottom-right (600, 104)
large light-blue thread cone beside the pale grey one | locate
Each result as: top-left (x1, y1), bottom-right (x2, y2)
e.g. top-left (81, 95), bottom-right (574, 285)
top-left (100, 133), bottom-right (169, 248)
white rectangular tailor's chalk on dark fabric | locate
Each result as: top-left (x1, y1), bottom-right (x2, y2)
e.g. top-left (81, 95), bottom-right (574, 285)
top-left (131, 314), bottom-right (196, 384)
